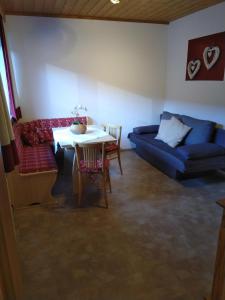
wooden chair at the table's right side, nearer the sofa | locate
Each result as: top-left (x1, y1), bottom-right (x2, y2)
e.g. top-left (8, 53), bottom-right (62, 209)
top-left (103, 124), bottom-right (123, 175)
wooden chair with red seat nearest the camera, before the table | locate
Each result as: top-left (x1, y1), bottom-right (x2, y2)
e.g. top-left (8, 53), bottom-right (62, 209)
top-left (75, 143), bottom-right (111, 208)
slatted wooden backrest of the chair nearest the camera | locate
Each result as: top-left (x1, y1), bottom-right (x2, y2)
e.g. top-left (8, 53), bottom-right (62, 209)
top-left (75, 143), bottom-right (105, 171)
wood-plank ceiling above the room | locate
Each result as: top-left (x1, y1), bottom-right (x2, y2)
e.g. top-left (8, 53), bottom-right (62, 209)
top-left (0, 0), bottom-right (224, 24)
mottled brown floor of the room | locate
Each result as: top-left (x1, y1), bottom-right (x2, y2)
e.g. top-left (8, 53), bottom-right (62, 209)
top-left (15, 151), bottom-right (225, 300)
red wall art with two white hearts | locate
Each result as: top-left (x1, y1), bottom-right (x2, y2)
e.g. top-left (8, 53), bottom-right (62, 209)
top-left (186, 32), bottom-right (225, 81)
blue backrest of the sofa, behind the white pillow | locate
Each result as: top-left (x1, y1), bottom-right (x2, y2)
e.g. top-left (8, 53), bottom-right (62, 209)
top-left (161, 111), bottom-right (216, 145)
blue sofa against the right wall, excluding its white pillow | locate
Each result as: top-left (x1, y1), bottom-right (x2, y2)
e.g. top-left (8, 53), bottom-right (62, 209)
top-left (128, 112), bottom-right (225, 179)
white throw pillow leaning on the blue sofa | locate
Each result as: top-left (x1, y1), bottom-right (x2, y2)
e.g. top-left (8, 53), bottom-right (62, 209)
top-left (155, 117), bottom-right (191, 148)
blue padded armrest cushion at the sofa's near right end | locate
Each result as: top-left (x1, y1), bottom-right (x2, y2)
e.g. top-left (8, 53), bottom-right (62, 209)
top-left (177, 143), bottom-right (225, 160)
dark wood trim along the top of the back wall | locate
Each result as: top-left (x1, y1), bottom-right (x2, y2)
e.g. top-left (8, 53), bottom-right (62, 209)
top-left (5, 11), bottom-right (169, 25)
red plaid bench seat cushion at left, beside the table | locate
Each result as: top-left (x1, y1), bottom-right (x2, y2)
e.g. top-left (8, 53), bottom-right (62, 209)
top-left (19, 145), bottom-right (57, 174)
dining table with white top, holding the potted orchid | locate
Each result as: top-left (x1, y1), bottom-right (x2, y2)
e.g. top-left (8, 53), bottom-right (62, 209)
top-left (52, 125), bottom-right (116, 194)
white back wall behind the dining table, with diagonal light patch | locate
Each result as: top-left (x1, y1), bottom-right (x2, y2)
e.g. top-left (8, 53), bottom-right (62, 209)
top-left (6, 16), bottom-right (168, 148)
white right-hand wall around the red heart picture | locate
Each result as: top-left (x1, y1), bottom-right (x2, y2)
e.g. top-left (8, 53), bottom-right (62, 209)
top-left (164, 3), bottom-right (225, 125)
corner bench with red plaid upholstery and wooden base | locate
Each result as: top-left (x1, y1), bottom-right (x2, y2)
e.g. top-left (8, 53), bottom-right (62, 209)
top-left (9, 117), bottom-right (87, 208)
